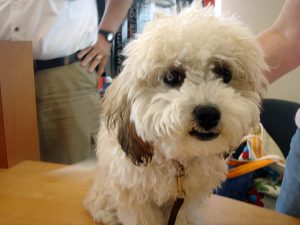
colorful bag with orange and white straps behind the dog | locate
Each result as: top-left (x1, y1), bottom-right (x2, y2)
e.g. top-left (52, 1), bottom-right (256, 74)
top-left (216, 124), bottom-right (285, 209)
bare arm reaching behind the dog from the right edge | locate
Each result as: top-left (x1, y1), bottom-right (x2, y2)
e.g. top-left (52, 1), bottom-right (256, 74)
top-left (257, 0), bottom-right (300, 83)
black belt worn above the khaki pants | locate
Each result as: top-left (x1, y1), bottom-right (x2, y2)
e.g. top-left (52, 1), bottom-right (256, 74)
top-left (34, 52), bottom-right (79, 71)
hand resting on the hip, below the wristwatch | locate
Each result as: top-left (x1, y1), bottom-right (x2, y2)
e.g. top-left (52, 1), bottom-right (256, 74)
top-left (77, 35), bottom-right (111, 75)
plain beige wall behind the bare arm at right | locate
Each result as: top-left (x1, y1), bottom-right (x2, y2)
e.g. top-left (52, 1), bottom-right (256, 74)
top-left (216, 0), bottom-right (300, 103)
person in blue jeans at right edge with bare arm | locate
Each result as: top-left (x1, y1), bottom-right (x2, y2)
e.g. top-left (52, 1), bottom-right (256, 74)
top-left (257, 0), bottom-right (300, 217)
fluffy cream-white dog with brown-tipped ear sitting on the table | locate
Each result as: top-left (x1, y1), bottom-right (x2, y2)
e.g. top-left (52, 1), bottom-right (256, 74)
top-left (85, 3), bottom-right (267, 225)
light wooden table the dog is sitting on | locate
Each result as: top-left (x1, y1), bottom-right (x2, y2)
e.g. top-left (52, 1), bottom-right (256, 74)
top-left (0, 161), bottom-right (300, 225)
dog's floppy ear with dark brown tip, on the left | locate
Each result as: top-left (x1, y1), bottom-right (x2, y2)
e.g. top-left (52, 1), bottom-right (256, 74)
top-left (102, 78), bottom-right (153, 165)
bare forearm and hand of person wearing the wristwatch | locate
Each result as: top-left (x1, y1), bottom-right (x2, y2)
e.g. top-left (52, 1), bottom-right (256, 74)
top-left (78, 0), bottom-right (133, 75)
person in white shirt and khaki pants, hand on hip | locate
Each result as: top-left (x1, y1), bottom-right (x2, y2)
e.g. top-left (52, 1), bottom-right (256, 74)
top-left (0, 0), bottom-right (132, 164)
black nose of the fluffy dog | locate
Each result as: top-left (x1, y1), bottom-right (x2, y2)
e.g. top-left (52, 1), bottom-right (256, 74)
top-left (193, 106), bottom-right (221, 130)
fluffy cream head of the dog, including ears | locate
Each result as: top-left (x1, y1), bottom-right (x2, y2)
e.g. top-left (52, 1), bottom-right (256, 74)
top-left (103, 6), bottom-right (267, 164)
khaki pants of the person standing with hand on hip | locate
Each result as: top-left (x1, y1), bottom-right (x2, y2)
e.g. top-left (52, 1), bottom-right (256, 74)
top-left (35, 63), bottom-right (100, 164)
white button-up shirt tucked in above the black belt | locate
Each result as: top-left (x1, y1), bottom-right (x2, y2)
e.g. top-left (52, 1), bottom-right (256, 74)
top-left (0, 0), bottom-right (98, 60)
